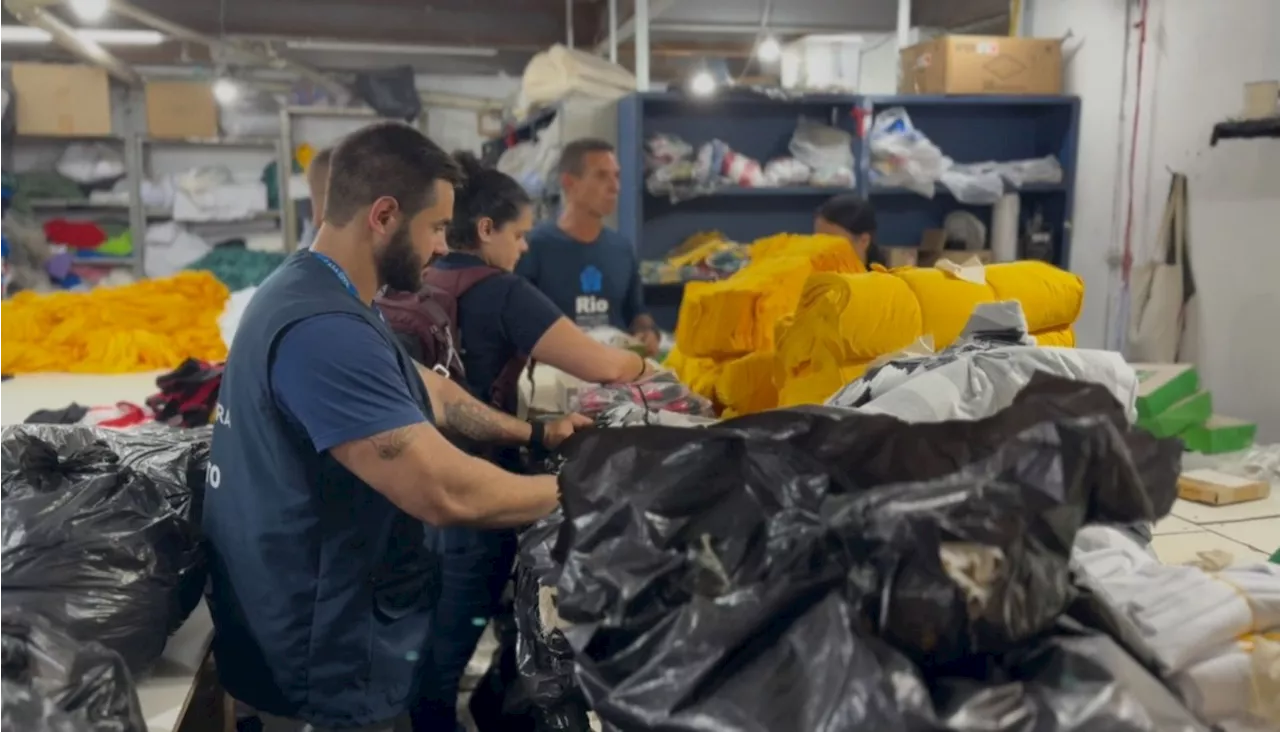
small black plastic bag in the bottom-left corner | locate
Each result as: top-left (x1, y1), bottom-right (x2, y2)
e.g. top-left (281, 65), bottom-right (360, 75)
top-left (0, 614), bottom-right (147, 732)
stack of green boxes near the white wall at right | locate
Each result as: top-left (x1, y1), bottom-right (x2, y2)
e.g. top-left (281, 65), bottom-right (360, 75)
top-left (1133, 363), bottom-right (1258, 454)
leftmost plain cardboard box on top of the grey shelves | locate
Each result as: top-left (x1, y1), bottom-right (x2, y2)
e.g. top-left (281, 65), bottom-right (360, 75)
top-left (13, 64), bottom-right (111, 137)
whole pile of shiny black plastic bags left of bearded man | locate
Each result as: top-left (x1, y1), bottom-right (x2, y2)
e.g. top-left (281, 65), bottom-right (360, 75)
top-left (0, 425), bottom-right (209, 732)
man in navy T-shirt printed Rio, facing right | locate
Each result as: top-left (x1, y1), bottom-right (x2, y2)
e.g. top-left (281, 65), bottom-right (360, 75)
top-left (516, 139), bottom-right (660, 356)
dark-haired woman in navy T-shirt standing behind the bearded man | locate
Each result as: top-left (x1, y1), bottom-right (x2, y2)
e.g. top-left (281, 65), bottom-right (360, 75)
top-left (413, 154), bottom-right (652, 732)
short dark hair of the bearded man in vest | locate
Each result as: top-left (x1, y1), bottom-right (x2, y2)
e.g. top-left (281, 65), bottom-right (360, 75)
top-left (324, 122), bottom-right (462, 227)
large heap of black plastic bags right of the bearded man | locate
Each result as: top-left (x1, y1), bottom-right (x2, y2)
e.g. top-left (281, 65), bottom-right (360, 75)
top-left (517, 375), bottom-right (1206, 732)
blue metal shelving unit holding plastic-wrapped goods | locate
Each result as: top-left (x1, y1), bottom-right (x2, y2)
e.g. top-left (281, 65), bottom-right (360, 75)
top-left (618, 92), bottom-right (1080, 328)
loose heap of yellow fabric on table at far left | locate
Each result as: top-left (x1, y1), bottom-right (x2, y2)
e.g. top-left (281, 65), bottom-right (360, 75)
top-left (0, 271), bottom-right (229, 374)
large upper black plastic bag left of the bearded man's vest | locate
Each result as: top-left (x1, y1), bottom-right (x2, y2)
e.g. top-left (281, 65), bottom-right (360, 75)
top-left (0, 427), bottom-right (206, 672)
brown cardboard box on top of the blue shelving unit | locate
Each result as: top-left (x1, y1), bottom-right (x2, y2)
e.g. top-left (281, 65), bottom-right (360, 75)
top-left (899, 36), bottom-right (1062, 95)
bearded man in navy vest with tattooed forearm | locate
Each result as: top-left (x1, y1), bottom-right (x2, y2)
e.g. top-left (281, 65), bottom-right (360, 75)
top-left (204, 123), bottom-right (586, 732)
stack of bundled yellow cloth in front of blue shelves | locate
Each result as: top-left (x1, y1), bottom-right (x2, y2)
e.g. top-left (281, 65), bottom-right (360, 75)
top-left (668, 234), bottom-right (1084, 416)
